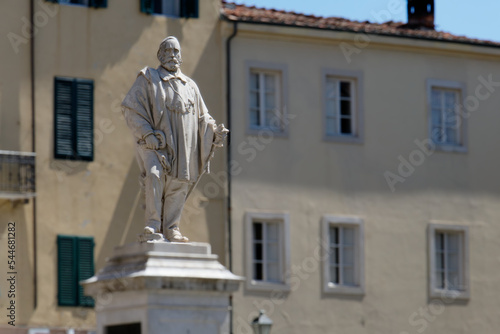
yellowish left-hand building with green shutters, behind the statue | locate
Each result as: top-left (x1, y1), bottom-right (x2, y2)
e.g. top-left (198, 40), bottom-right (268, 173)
top-left (0, 0), bottom-right (226, 333)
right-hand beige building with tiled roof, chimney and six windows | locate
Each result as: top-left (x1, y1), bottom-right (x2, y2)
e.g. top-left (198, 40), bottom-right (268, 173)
top-left (224, 1), bottom-right (500, 334)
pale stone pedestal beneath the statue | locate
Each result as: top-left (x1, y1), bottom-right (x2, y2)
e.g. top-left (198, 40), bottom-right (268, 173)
top-left (83, 242), bottom-right (243, 334)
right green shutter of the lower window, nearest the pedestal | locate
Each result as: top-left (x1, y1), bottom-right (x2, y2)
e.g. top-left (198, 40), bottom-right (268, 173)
top-left (77, 237), bottom-right (94, 307)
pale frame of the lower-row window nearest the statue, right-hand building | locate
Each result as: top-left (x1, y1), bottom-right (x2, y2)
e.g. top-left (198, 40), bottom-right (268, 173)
top-left (245, 212), bottom-right (290, 291)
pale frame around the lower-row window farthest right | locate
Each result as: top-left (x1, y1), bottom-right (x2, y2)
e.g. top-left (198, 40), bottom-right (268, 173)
top-left (427, 224), bottom-right (470, 299)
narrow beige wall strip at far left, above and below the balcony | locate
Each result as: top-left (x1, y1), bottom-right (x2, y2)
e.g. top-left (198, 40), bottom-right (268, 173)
top-left (0, 1), bottom-right (33, 325)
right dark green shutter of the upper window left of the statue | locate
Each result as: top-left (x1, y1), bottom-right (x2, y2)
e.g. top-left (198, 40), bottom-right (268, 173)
top-left (74, 79), bottom-right (94, 161)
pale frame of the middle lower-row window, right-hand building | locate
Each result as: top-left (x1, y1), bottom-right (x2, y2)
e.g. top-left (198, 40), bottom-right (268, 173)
top-left (321, 215), bottom-right (365, 295)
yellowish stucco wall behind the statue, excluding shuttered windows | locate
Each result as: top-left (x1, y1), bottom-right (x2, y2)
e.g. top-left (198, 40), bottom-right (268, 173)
top-left (0, 0), bottom-right (226, 329)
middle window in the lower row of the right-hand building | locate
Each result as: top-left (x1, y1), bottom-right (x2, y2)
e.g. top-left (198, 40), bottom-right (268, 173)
top-left (322, 216), bottom-right (364, 294)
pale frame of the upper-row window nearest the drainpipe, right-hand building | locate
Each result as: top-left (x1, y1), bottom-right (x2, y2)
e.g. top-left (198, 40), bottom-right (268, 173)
top-left (245, 61), bottom-right (288, 137)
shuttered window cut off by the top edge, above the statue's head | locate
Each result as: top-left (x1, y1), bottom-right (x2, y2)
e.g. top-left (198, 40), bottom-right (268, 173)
top-left (141, 0), bottom-right (199, 18)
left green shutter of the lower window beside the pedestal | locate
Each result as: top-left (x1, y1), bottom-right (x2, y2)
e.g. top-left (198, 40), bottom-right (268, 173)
top-left (57, 235), bottom-right (78, 306)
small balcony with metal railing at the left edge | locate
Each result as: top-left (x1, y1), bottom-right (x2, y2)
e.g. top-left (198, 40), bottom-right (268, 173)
top-left (0, 150), bottom-right (36, 200)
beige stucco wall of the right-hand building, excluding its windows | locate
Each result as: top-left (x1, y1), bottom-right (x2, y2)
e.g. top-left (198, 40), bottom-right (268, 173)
top-left (227, 24), bottom-right (500, 334)
